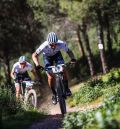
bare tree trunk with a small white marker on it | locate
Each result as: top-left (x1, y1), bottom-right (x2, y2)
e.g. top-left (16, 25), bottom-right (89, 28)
top-left (97, 10), bottom-right (108, 73)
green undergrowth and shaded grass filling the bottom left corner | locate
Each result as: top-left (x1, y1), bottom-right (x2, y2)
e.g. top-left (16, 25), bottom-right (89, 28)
top-left (0, 87), bottom-right (45, 129)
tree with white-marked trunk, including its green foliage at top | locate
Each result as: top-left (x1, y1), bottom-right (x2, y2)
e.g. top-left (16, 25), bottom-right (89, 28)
top-left (77, 0), bottom-right (108, 73)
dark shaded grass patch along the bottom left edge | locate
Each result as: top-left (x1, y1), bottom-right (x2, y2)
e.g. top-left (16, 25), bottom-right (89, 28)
top-left (2, 111), bottom-right (45, 129)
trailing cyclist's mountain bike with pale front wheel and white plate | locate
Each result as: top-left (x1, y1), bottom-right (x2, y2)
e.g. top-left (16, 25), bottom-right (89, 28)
top-left (19, 80), bottom-right (37, 109)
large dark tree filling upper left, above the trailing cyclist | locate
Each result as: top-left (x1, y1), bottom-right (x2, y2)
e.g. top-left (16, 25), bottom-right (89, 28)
top-left (0, 0), bottom-right (42, 84)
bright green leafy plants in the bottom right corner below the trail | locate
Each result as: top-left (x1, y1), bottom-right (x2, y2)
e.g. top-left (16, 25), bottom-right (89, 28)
top-left (63, 96), bottom-right (120, 129)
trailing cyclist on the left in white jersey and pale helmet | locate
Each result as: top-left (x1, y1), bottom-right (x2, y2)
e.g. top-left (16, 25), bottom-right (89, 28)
top-left (11, 56), bottom-right (37, 98)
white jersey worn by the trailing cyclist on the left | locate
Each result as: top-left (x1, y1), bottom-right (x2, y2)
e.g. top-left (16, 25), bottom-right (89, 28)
top-left (12, 62), bottom-right (33, 73)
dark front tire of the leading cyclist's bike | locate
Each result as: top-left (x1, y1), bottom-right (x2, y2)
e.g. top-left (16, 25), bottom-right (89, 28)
top-left (56, 78), bottom-right (67, 115)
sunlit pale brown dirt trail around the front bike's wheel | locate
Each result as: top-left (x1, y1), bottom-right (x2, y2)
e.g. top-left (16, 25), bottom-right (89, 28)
top-left (38, 85), bottom-right (101, 115)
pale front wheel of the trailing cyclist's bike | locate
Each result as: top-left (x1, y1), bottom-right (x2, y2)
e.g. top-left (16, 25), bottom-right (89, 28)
top-left (25, 89), bottom-right (37, 109)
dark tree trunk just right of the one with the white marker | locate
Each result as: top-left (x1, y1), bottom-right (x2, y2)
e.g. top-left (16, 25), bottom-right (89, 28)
top-left (104, 13), bottom-right (113, 56)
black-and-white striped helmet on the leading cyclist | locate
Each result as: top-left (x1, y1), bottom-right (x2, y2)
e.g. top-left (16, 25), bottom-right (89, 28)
top-left (47, 32), bottom-right (58, 44)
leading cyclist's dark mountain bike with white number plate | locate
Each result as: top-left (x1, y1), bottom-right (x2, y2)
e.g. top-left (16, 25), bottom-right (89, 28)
top-left (46, 64), bottom-right (67, 115)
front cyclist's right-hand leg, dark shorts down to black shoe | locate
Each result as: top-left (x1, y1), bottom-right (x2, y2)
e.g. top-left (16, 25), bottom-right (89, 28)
top-left (54, 52), bottom-right (72, 96)
